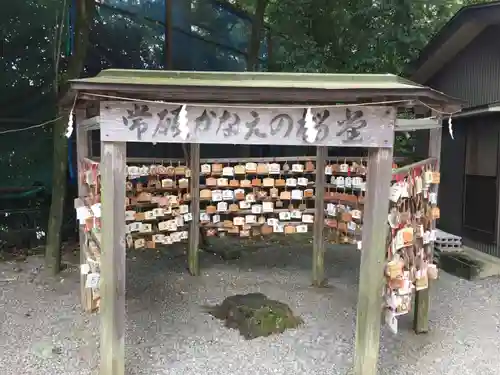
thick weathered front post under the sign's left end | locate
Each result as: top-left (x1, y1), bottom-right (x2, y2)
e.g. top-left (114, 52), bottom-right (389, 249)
top-left (100, 142), bottom-right (126, 375)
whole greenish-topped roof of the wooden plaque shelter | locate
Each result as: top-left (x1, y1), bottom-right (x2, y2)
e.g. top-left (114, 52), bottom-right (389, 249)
top-left (70, 69), bottom-right (461, 112)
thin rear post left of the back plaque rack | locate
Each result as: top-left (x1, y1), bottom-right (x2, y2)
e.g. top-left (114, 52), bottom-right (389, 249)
top-left (188, 143), bottom-right (200, 276)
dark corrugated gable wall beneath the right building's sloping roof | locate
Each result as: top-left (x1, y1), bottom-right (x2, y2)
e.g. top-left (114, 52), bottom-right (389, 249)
top-left (426, 25), bottom-right (500, 107)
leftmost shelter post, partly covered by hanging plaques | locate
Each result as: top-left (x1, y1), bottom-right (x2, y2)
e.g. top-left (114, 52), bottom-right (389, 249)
top-left (75, 109), bottom-right (92, 312)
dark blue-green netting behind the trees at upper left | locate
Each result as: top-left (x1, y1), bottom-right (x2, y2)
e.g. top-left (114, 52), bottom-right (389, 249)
top-left (0, 0), bottom-right (267, 191)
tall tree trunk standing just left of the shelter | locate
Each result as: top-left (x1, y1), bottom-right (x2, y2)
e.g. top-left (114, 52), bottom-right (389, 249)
top-left (45, 0), bottom-right (95, 275)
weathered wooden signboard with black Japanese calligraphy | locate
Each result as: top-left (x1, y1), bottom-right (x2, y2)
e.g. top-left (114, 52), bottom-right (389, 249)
top-left (100, 102), bottom-right (396, 147)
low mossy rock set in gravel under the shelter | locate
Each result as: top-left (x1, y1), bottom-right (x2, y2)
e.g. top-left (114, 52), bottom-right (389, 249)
top-left (208, 293), bottom-right (303, 340)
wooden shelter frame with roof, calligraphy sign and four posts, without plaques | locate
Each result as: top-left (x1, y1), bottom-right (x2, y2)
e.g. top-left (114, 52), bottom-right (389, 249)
top-left (71, 71), bottom-right (457, 375)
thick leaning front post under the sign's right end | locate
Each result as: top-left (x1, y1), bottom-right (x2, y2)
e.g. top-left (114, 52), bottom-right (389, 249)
top-left (354, 148), bottom-right (392, 375)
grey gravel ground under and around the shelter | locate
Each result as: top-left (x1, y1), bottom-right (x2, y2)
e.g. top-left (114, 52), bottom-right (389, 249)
top-left (0, 238), bottom-right (500, 375)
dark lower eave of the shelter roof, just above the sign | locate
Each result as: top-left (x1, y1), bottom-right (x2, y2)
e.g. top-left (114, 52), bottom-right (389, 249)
top-left (72, 81), bottom-right (463, 113)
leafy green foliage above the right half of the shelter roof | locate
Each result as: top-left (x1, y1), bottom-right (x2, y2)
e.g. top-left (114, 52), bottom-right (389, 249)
top-left (264, 0), bottom-right (461, 74)
